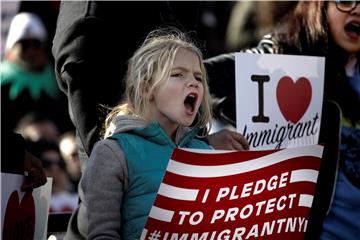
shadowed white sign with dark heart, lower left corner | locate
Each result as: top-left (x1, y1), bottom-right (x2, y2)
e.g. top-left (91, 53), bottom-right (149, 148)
top-left (0, 173), bottom-right (52, 240)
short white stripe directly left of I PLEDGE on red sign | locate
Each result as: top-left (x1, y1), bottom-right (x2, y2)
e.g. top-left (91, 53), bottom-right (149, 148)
top-left (158, 183), bottom-right (199, 201)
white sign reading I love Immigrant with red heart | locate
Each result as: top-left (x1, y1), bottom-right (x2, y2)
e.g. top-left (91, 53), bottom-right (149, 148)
top-left (235, 53), bottom-right (325, 150)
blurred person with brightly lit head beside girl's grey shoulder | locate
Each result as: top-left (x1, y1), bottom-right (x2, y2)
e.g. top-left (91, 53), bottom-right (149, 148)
top-left (59, 131), bottom-right (81, 192)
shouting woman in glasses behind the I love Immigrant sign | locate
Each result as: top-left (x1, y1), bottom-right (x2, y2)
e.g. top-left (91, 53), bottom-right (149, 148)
top-left (205, 1), bottom-right (360, 239)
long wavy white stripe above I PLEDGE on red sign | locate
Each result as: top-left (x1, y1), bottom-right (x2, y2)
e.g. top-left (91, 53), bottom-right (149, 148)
top-left (166, 145), bottom-right (323, 178)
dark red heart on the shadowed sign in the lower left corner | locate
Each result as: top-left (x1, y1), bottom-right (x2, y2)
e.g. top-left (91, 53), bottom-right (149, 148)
top-left (3, 191), bottom-right (35, 240)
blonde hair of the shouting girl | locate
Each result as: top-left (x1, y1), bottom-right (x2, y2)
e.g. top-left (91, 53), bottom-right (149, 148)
top-left (104, 28), bottom-right (211, 137)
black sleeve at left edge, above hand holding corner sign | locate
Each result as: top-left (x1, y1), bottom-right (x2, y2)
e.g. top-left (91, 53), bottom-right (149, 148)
top-left (1, 130), bottom-right (25, 174)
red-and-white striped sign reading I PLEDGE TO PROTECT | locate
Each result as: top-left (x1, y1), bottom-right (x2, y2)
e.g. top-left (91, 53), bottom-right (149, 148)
top-left (141, 145), bottom-right (323, 240)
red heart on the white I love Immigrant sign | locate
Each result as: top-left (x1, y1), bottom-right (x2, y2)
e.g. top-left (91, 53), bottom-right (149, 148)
top-left (276, 76), bottom-right (312, 123)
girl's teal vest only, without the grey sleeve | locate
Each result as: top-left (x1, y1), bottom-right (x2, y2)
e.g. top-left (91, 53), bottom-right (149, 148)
top-left (113, 123), bottom-right (209, 239)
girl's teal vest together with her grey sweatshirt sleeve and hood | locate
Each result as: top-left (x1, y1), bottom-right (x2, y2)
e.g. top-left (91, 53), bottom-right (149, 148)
top-left (81, 115), bottom-right (211, 240)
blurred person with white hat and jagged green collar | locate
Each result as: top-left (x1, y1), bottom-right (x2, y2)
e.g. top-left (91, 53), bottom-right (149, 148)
top-left (0, 9), bottom-right (71, 137)
